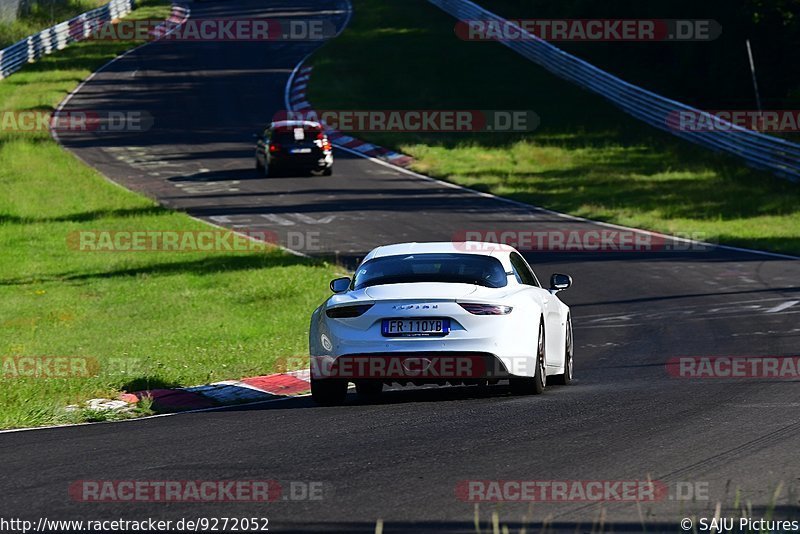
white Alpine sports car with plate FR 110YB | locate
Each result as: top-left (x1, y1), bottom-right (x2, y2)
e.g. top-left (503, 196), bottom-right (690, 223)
top-left (309, 242), bottom-right (573, 405)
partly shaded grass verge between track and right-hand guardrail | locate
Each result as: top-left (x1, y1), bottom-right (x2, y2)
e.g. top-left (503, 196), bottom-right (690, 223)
top-left (309, 0), bottom-right (800, 254)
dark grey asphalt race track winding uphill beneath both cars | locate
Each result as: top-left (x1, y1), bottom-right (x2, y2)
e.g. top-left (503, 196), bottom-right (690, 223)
top-left (0, 0), bottom-right (800, 532)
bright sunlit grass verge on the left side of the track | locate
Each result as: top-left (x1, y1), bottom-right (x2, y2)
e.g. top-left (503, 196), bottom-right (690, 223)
top-left (0, 3), bottom-right (336, 428)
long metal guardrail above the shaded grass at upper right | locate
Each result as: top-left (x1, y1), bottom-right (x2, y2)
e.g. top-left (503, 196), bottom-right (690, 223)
top-left (428, 0), bottom-right (800, 182)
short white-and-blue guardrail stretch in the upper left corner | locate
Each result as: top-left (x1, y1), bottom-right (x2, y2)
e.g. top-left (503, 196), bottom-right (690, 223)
top-left (0, 0), bottom-right (134, 80)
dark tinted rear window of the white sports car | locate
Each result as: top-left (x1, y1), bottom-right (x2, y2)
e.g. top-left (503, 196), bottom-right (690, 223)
top-left (353, 253), bottom-right (508, 289)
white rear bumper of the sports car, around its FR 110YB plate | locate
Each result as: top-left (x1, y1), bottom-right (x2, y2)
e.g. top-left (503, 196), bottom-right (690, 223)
top-left (309, 298), bottom-right (539, 383)
